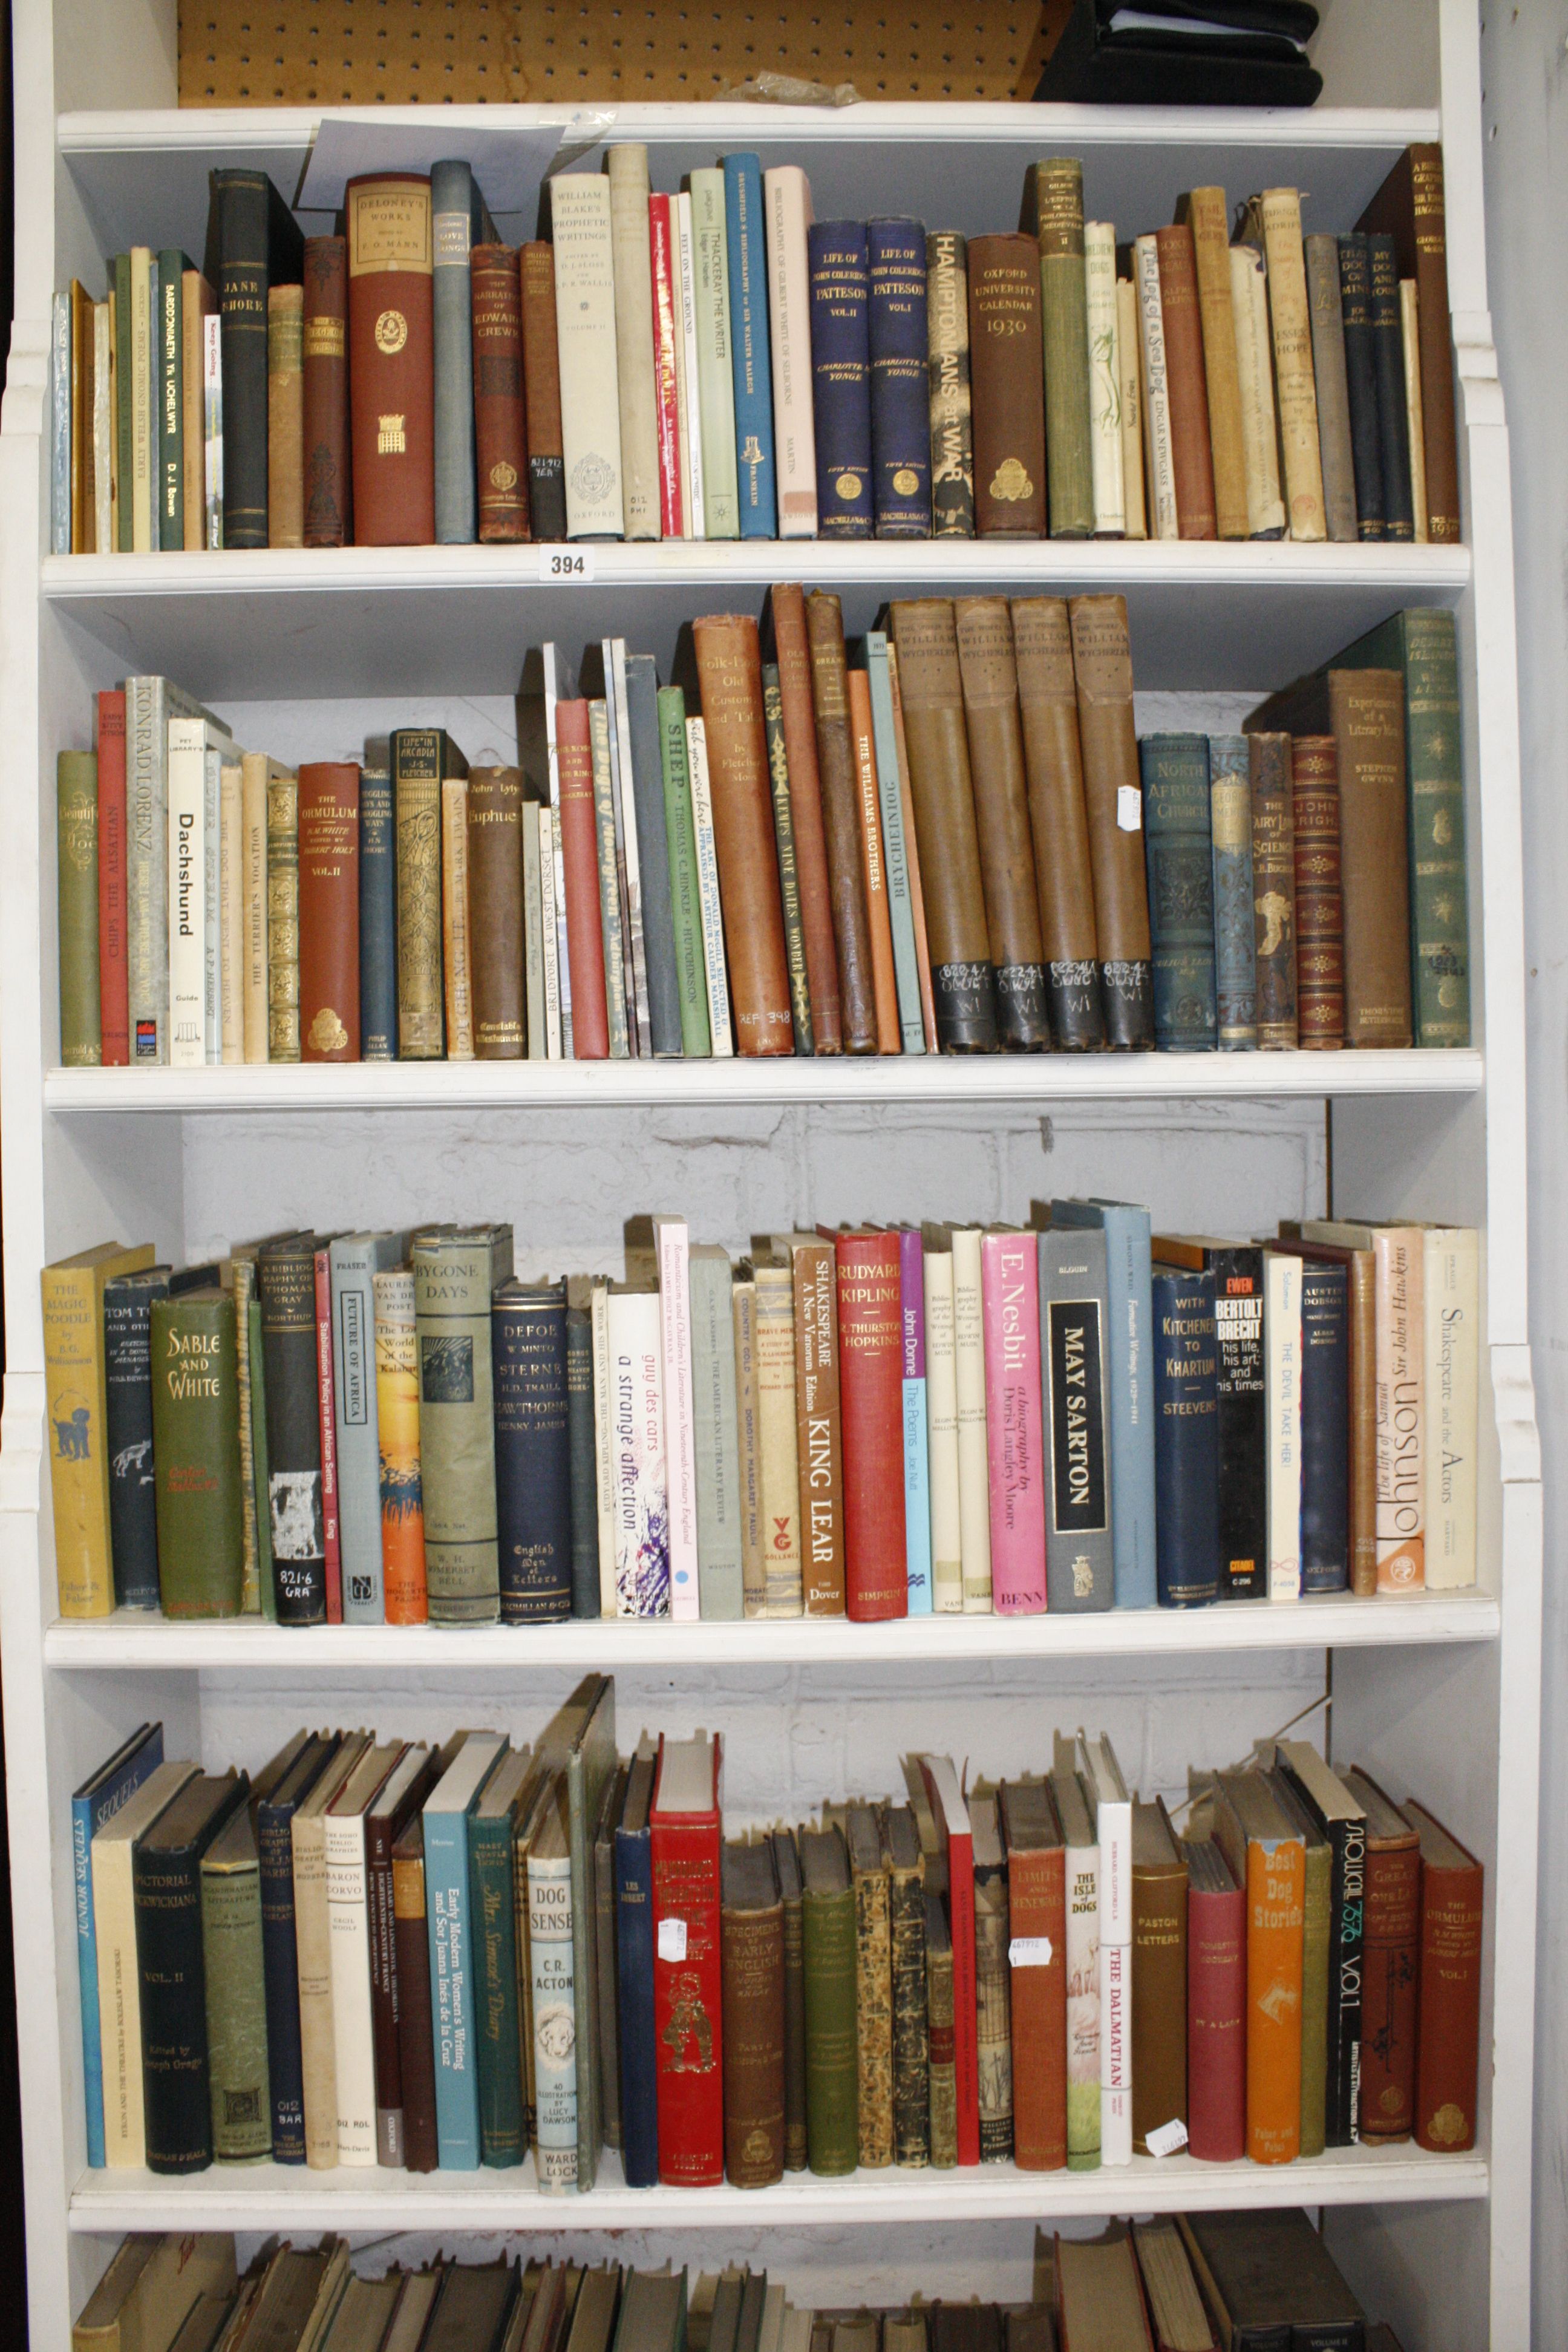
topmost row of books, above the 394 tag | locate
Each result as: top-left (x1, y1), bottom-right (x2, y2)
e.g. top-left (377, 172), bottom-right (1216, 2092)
top-left (54, 141), bottom-right (1460, 553)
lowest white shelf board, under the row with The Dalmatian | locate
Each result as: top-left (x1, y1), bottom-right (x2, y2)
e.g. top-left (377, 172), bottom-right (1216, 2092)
top-left (71, 2143), bottom-right (1488, 2235)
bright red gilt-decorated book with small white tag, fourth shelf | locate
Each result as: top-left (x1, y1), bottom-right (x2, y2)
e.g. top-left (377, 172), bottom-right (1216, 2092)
top-left (649, 1745), bottom-right (724, 2190)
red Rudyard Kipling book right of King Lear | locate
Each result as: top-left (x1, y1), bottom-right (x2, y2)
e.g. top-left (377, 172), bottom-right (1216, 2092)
top-left (835, 1232), bottom-right (907, 1618)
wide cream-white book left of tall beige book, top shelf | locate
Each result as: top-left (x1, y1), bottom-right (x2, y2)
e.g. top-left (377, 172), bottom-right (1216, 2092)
top-left (550, 175), bottom-right (625, 538)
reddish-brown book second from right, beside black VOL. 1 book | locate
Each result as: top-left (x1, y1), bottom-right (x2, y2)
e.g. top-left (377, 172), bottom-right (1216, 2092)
top-left (1340, 1766), bottom-right (1422, 2140)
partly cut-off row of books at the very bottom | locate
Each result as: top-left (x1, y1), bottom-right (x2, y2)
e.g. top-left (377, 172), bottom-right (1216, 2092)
top-left (73, 2211), bottom-right (1399, 2352)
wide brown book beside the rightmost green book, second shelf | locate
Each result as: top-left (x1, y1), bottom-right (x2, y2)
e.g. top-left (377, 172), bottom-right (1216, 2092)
top-left (1328, 670), bottom-right (1413, 1047)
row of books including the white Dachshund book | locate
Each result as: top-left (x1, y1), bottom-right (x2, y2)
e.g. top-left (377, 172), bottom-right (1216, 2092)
top-left (59, 586), bottom-right (1469, 1068)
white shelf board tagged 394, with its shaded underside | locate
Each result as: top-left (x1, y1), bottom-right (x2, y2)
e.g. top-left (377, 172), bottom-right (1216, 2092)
top-left (42, 538), bottom-right (1472, 701)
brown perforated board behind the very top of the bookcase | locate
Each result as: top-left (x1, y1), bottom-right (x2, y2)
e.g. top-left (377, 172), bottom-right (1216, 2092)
top-left (178, 0), bottom-right (1048, 106)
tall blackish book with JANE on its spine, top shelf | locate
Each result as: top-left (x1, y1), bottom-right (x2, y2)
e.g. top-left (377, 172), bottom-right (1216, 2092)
top-left (206, 169), bottom-right (305, 548)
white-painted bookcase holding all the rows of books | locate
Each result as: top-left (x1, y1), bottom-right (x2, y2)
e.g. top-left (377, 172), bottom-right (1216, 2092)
top-left (0, 0), bottom-right (1542, 2352)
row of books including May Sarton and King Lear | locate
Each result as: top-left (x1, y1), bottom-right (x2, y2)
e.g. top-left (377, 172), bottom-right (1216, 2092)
top-left (42, 1200), bottom-right (1478, 1639)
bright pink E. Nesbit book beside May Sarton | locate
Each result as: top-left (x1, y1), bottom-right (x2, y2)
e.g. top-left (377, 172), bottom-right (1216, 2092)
top-left (980, 1232), bottom-right (1046, 1616)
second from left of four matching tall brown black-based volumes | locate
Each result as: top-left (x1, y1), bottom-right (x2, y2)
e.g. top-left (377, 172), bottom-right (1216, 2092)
top-left (952, 595), bottom-right (1051, 1054)
